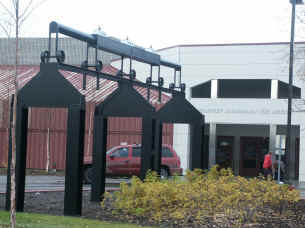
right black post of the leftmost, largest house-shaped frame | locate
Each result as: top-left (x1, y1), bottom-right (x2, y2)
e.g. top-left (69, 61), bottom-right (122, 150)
top-left (64, 105), bottom-right (85, 216)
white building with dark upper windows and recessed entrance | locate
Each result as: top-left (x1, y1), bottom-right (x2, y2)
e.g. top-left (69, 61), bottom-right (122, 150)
top-left (113, 42), bottom-right (305, 181)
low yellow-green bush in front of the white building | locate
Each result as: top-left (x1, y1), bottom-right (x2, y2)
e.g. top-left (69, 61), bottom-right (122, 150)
top-left (102, 166), bottom-right (299, 226)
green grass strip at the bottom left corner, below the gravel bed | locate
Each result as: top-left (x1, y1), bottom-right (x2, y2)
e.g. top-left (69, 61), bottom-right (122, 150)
top-left (0, 211), bottom-right (152, 228)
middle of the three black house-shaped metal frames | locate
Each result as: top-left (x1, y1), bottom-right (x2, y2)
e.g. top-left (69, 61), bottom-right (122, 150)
top-left (91, 80), bottom-right (155, 201)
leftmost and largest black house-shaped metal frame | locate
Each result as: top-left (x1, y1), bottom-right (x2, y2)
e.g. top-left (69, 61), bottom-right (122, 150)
top-left (7, 63), bottom-right (85, 215)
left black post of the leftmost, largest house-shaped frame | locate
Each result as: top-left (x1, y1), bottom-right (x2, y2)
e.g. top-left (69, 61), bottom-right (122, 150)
top-left (15, 105), bottom-right (28, 212)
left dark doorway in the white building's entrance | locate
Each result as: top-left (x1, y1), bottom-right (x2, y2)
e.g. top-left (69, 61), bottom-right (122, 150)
top-left (216, 136), bottom-right (234, 169)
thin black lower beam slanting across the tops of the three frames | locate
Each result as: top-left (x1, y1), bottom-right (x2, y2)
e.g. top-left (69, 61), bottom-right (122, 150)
top-left (58, 63), bottom-right (182, 94)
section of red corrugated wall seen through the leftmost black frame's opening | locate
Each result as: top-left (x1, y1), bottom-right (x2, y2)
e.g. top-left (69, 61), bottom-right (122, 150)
top-left (27, 108), bottom-right (68, 169)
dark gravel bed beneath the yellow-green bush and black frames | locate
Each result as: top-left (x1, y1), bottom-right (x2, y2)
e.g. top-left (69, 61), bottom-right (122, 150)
top-left (0, 191), bottom-right (305, 228)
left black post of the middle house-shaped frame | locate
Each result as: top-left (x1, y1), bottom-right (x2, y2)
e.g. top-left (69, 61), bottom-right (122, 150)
top-left (91, 114), bottom-right (108, 202)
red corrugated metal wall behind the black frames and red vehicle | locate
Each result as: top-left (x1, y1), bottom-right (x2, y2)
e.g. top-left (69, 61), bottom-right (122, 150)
top-left (0, 102), bottom-right (173, 169)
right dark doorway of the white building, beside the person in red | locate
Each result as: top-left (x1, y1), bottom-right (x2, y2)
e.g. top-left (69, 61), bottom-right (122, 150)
top-left (240, 137), bottom-right (269, 177)
